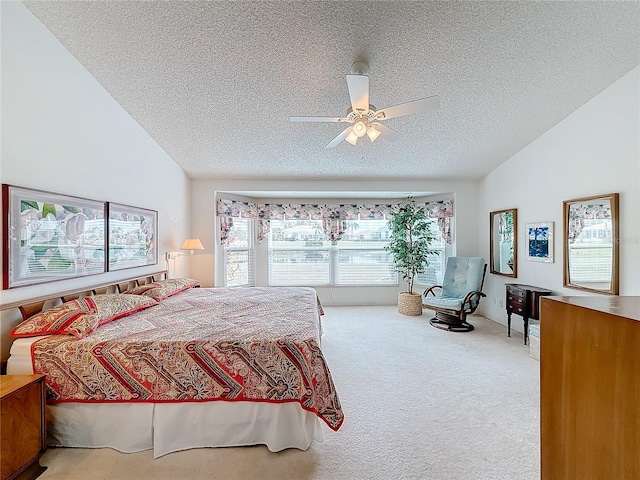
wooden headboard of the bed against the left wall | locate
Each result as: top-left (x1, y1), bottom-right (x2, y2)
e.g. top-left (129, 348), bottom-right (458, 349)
top-left (0, 270), bottom-right (167, 370)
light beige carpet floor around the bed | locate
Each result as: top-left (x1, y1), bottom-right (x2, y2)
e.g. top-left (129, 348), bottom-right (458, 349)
top-left (35, 306), bottom-right (540, 480)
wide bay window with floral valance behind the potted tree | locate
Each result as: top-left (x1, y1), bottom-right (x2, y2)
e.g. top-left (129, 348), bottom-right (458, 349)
top-left (216, 199), bottom-right (453, 287)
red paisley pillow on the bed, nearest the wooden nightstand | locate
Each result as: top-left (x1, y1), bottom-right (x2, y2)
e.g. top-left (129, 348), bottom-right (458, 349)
top-left (9, 294), bottom-right (158, 338)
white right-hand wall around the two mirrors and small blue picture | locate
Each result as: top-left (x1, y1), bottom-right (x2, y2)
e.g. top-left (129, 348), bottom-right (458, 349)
top-left (478, 67), bottom-right (640, 332)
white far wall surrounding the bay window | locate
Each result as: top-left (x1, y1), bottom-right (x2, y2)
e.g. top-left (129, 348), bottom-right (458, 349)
top-left (191, 179), bottom-right (479, 305)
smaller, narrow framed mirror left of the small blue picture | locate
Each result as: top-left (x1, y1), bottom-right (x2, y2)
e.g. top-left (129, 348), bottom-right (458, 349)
top-left (489, 208), bottom-right (518, 278)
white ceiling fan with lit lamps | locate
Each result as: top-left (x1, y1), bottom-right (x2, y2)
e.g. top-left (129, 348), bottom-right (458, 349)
top-left (289, 62), bottom-right (440, 148)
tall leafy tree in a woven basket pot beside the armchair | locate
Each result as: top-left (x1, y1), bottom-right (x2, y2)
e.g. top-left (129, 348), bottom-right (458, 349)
top-left (384, 196), bottom-right (438, 315)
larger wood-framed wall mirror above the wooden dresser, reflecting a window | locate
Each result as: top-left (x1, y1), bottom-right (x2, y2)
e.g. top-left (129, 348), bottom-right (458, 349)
top-left (563, 193), bottom-right (620, 295)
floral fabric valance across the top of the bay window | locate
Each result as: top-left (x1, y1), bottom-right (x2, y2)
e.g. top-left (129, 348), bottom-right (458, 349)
top-left (216, 198), bottom-right (453, 244)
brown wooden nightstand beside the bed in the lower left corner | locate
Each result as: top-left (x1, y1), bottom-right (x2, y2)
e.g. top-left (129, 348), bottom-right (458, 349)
top-left (0, 375), bottom-right (46, 480)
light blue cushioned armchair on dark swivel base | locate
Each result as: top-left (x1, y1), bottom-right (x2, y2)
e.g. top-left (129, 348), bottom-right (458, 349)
top-left (422, 257), bottom-right (487, 332)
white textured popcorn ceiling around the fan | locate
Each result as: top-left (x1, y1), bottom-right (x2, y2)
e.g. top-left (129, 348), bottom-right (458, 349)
top-left (24, 1), bottom-right (640, 179)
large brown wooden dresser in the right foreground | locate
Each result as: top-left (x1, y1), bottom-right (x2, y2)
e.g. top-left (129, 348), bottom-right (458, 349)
top-left (540, 296), bottom-right (640, 480)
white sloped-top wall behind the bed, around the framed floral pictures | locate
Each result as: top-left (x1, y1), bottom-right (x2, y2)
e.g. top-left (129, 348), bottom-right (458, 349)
top-left (0, 2), bottom-right (190, 358)
